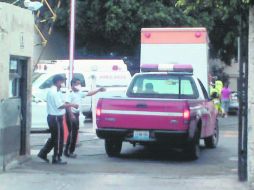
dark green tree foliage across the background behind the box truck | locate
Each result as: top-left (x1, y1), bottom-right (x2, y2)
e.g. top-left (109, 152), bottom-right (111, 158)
top-left (2, 0), bottom-right (254, 64)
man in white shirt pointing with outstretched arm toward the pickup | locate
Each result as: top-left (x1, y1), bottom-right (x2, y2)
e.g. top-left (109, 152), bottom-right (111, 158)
top-left (64, 78), bottom-right (105, 158)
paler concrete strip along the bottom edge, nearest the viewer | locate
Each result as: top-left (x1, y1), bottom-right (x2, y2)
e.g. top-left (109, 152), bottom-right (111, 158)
top-left (0, 170), bottom-right (248, 190)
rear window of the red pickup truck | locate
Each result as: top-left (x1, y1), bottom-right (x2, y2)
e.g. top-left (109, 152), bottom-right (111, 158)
top-left (127, 74), bottom-right (199, 99)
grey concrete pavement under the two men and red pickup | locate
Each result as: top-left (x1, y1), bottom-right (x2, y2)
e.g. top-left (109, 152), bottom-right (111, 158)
top-left (0, 118), bottom-right (249, 190)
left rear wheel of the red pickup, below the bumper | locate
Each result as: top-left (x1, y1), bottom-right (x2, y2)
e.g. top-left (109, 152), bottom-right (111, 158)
top-left (105, 139), bottom-right (122, 157)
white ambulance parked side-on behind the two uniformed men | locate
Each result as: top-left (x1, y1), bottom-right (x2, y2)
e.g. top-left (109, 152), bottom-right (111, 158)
top-left (32, 59), bottom-right (131, 122)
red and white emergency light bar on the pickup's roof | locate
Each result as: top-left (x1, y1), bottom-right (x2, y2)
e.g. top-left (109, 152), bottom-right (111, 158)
top-left (140, 64), bottom-right (193, 73)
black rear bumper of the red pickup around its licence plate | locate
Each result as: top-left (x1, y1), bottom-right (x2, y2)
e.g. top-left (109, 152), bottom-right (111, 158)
top-left (96, 128), bottom-right (190, 145)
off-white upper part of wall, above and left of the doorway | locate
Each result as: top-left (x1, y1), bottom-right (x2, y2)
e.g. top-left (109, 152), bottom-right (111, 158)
top-left (0, 2), bottom-right (34, 100)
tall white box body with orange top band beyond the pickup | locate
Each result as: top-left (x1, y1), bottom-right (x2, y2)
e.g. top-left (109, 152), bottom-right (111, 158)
top-left (140, 28), bottom-right (209, 90)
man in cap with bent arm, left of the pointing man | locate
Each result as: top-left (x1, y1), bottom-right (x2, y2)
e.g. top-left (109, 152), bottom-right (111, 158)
top-left (38, 75), bottom-right (78, 164)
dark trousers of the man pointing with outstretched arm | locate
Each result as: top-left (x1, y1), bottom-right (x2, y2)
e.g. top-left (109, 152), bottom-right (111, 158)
top-left (65, 112), bottom-right (79, 154)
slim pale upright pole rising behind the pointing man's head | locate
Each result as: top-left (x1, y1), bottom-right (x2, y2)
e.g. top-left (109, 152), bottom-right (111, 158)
top-left (68, 0), bottom-right (76, 87)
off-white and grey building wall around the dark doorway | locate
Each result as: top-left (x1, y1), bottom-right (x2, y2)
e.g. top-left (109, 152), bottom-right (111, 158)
top-left (0, 2), bottom-right (34, 170)
